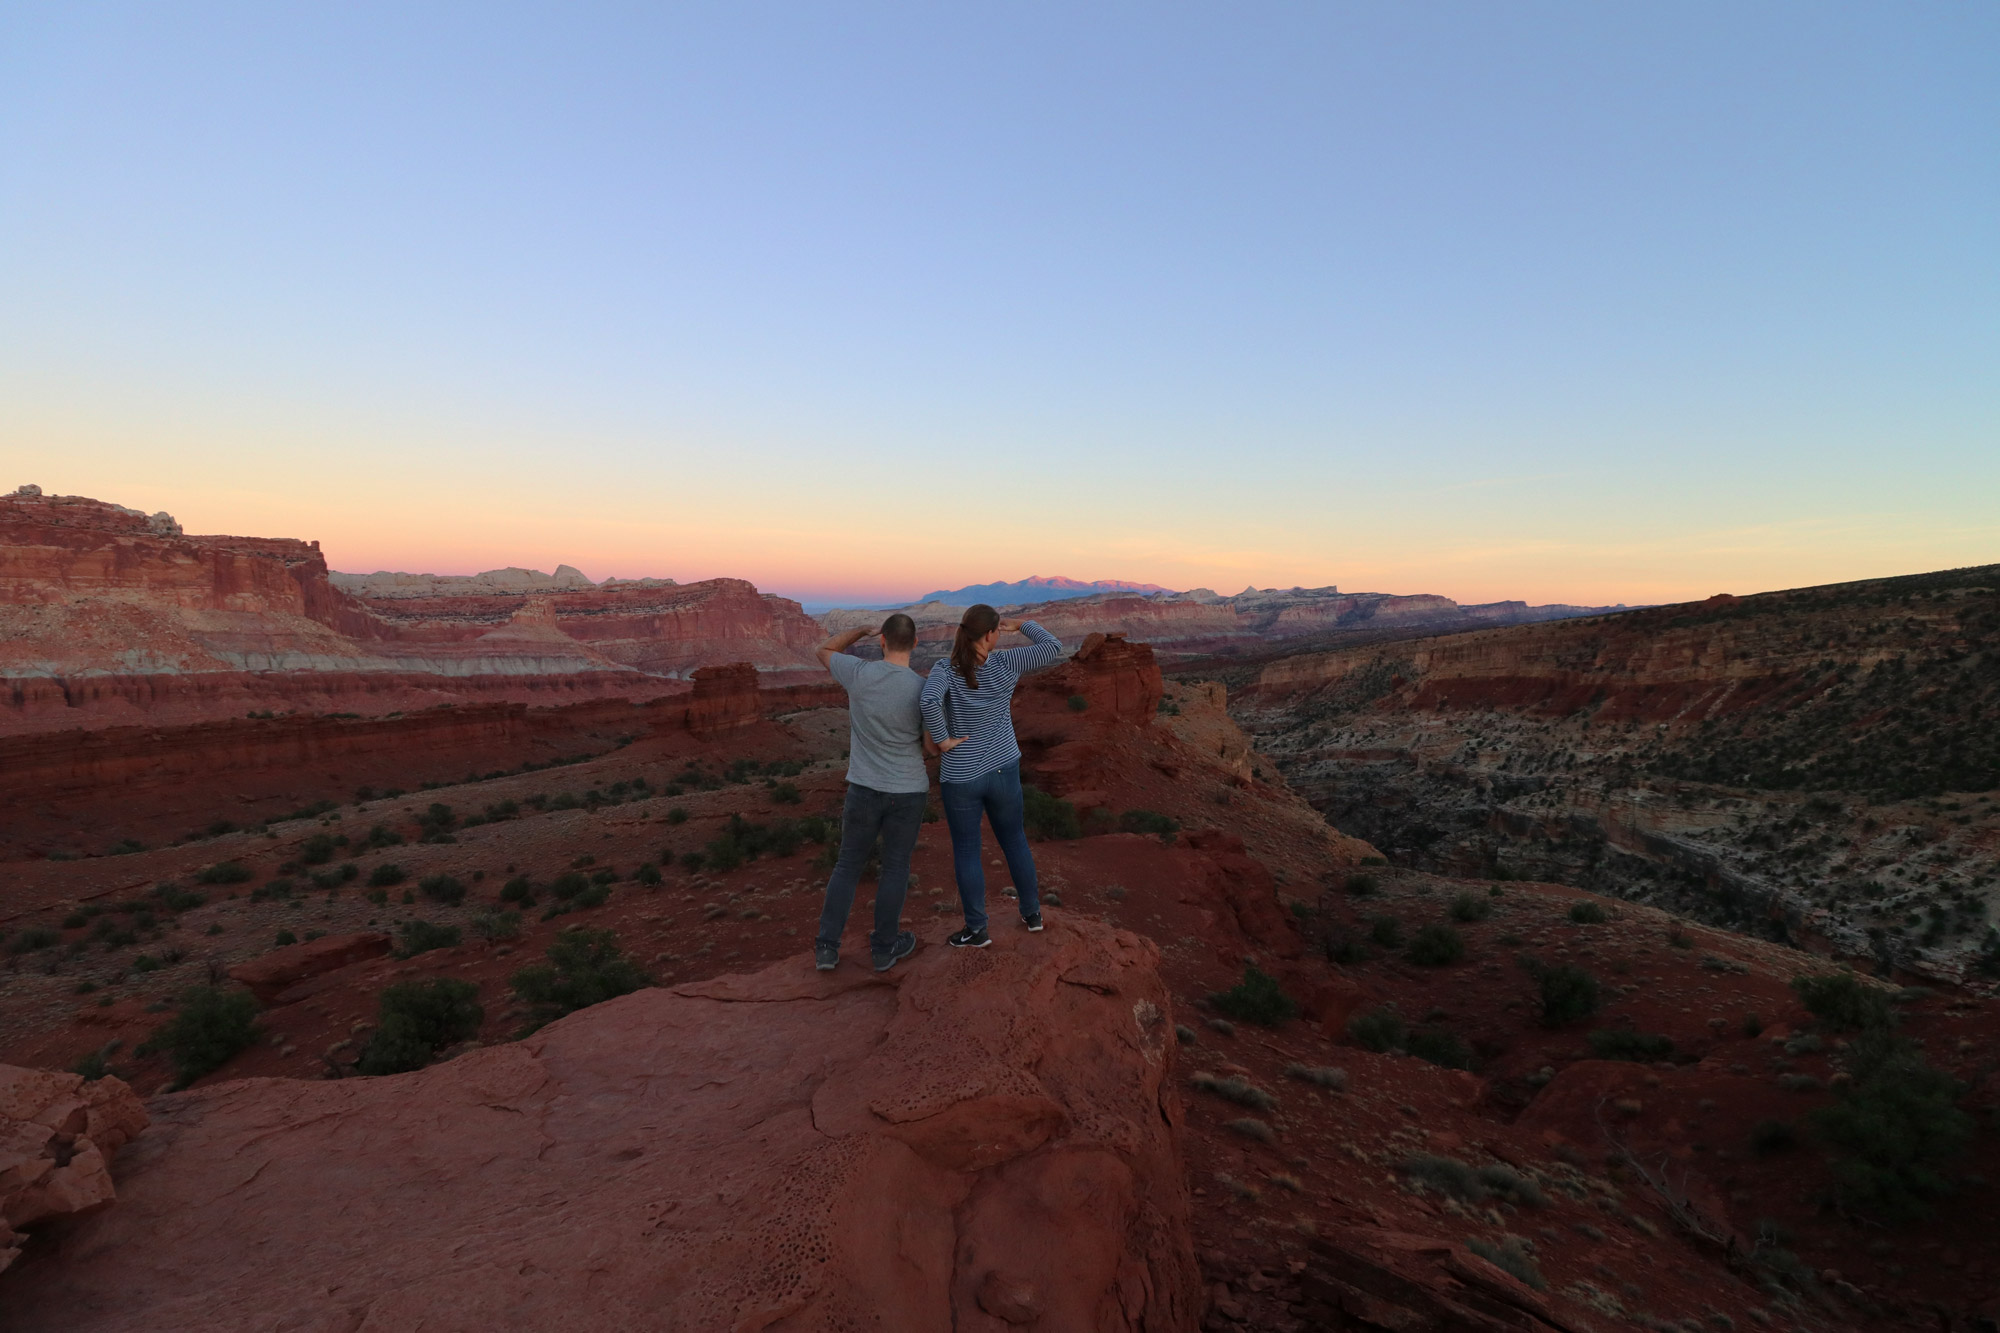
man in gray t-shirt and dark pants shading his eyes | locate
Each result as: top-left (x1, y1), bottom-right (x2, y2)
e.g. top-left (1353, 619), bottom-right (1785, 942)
top-left (812, 612), bottom-right (930, 973)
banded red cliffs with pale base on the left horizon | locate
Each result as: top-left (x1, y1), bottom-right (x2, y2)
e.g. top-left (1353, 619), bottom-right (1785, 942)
top-left (0, 488), bottom-right (822, 735)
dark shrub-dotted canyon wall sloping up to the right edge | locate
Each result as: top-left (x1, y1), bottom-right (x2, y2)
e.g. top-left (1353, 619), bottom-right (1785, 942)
top-left (1236, 566), bottom-right (2000, 977)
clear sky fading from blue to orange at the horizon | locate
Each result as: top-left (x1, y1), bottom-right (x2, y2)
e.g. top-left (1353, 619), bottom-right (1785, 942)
top-left (0, 0), bottom-right (2000, 602)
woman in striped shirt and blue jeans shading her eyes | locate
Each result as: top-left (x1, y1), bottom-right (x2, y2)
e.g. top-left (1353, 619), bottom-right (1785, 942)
top-left (918, 602), bottom-right (1062, 949)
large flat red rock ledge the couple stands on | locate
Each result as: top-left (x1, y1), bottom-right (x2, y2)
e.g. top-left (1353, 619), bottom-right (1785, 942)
top-left (6, 917), bottom-right (1200, 1333)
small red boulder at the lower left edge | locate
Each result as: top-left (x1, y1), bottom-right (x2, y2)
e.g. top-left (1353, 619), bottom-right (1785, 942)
top-left (0, 1065), bottom-right (146, 1269)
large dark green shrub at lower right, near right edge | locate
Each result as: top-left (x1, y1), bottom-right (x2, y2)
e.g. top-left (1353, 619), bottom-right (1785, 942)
top-left (1812, 1027), bottom-right (1972, 1221)
